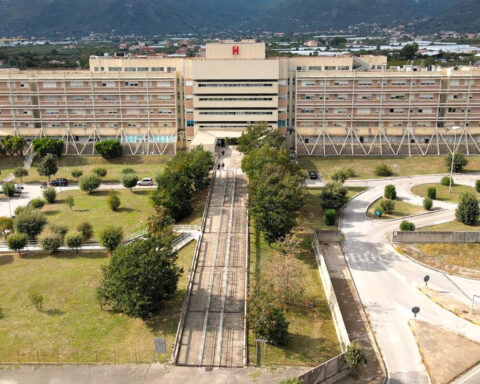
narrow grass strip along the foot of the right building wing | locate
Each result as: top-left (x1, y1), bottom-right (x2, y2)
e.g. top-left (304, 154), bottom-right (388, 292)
top-left (298, 156), bottom-right (480, 180)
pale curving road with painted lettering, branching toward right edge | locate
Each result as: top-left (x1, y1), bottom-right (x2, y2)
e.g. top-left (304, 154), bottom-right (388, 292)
top-left (340, 175), bottom-right (480, 384)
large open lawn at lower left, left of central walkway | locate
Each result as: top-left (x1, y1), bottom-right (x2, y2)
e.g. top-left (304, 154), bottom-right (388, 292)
top-left (0, 242), bottom-right (195, 363)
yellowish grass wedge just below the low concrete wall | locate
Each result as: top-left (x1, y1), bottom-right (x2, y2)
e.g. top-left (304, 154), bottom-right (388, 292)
top-left (415, 244), bottom-right (480, 270)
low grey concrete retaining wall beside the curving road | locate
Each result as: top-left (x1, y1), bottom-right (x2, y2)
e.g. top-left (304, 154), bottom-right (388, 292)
top-left (392, 231), bottom-right (480, 244)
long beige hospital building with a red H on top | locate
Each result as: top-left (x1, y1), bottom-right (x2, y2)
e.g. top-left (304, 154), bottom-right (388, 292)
top-left (0, 41), bottom-right (480, 156)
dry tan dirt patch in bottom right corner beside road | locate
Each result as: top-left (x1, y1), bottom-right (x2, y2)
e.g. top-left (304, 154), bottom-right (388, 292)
top-left (410, 320), bottom-right (480, 384)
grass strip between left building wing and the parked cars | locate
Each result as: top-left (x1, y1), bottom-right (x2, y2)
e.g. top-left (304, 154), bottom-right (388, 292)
top-left (12, 156), bottom-right (171, 183)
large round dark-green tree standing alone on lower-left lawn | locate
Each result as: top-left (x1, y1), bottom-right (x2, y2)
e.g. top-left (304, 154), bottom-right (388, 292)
top-left (98, 238), bottom-right (182, 318)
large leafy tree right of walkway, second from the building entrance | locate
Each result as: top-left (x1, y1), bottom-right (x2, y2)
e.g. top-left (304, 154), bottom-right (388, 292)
top-left (248, 165), bottom-right (305, 243)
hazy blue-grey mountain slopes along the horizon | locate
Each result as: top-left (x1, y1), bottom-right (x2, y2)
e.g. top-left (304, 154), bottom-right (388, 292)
top-left (0, 0), bottom-right (480, 36)
